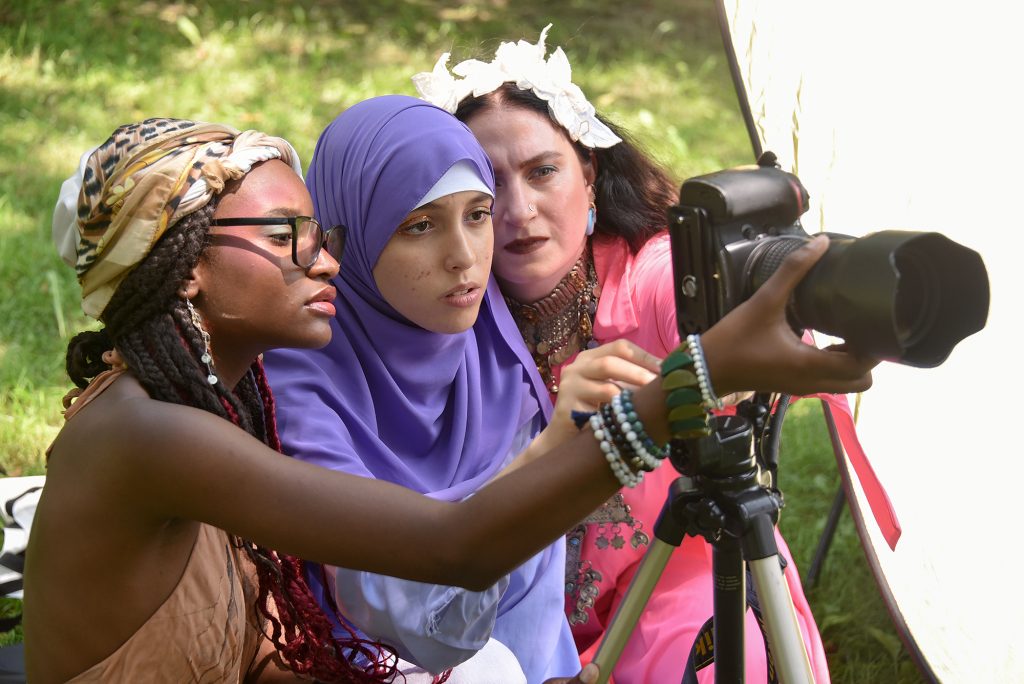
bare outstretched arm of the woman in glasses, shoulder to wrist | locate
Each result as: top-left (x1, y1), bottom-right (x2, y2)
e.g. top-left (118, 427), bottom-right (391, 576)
top-left (114, 366), bottom-right (666, 590)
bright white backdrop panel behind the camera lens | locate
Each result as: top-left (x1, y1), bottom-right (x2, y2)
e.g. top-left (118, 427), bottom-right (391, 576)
top-left (724, 0), bottom-right (1024, 682)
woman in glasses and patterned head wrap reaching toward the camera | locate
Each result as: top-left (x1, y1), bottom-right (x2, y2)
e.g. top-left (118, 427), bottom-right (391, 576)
top-left (24, 113), bottom-right (869, 682)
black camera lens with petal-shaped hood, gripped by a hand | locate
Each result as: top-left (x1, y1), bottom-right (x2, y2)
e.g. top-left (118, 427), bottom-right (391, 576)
top-left (745, 230), bottom-right (989, 368)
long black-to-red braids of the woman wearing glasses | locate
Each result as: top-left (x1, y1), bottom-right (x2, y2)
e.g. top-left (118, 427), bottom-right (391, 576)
top-left (67, 197), bottom-right (396, 682)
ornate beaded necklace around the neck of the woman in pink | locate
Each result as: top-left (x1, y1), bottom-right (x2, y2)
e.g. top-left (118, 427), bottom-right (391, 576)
top-left (505, 249), bottom-right (598, 394)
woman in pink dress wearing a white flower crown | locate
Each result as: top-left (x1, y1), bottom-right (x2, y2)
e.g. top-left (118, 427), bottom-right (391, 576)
top-left (413, 25), bottom-right (828, 684)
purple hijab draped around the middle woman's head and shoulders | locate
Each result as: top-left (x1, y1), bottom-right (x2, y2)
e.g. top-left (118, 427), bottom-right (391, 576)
top-left (265, 95), bottom-right (550, 501)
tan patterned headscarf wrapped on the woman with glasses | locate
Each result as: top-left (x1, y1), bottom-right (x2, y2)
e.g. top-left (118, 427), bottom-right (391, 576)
top-left (53, 119), bottom-right (302, 318)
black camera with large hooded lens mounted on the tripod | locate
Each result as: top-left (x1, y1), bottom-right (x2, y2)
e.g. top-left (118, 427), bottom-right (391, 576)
top-left (669, 153), bottom-right (989, 368)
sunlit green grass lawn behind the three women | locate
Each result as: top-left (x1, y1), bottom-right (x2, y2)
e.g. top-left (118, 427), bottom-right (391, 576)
top-left (0, 0), bottom-right (916, 683)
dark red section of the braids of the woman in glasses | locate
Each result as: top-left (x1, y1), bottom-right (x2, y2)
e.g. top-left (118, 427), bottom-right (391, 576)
top-left (251, 360), bottom-right (396, 682)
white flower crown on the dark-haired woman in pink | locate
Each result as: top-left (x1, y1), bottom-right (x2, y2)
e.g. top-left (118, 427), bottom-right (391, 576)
top-left (413, 24), bottom-right (622, 148)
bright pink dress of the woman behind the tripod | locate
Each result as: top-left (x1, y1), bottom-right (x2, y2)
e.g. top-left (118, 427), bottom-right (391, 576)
top-left (553, 233), bottom-right (829, 684)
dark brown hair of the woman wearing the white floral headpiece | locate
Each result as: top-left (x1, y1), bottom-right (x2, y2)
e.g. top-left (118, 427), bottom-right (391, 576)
top-left (455, 83), bottom-right (677, 252)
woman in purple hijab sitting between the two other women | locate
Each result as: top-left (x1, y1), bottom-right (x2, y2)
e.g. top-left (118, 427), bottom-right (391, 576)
top-left (265, 95), bottom-right (598, 684)
